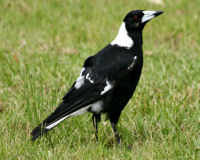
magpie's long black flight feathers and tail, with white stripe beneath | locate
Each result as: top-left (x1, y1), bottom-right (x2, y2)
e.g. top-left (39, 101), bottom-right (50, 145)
top-left (31, 84), bottom-right (106, 141)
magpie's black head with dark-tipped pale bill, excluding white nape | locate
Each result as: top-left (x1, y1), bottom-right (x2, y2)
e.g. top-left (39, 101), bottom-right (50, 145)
top-left (123, 10), bottom-right (163, 32)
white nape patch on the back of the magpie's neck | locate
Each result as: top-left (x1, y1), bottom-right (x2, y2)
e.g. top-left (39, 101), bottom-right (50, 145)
top-left (111, 22), bottom-right (134, 49)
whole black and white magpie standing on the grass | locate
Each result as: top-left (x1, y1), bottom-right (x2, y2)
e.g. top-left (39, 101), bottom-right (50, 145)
top-left (31, 10), bottom-right (163, 143)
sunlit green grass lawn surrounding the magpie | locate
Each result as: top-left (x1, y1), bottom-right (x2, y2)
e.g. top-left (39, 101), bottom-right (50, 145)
top-left (0, 0), bottom-right (200, 160)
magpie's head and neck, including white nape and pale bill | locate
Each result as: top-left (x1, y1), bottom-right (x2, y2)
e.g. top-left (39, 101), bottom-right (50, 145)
top-left (111, 10), bottom-right (163, 49)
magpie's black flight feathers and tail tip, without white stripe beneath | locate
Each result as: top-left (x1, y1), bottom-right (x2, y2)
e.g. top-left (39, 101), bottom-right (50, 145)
top-left (31, 82), bottom-right (109, 141)
